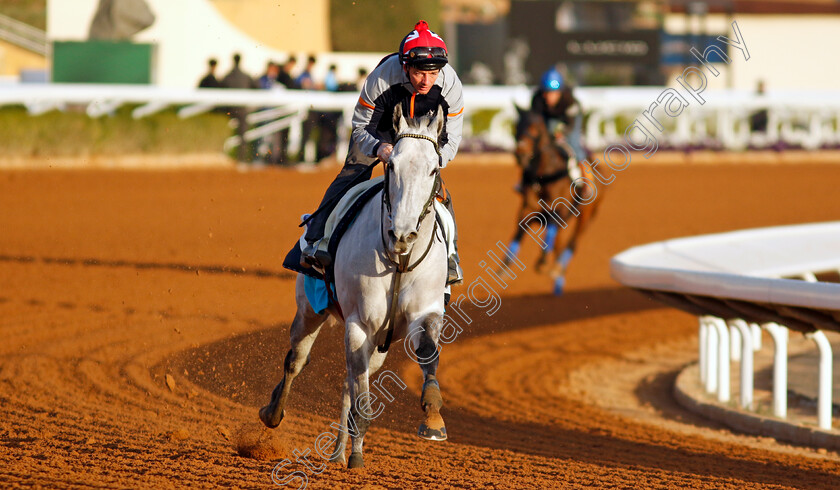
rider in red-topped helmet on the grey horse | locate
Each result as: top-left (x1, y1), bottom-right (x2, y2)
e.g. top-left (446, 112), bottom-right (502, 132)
top-left (301, 20), bottom-right (464, 284)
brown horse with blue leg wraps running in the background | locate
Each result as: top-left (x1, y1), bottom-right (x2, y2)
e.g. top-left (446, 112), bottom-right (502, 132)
top-left (508, 107), bottom-right (603, 295)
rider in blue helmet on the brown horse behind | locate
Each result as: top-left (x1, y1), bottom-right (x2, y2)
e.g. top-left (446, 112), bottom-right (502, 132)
top-left (531, 67), bottom-right (587, 185)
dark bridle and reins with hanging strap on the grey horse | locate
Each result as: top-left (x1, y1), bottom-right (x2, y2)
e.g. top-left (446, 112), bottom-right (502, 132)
top-left (376, 133), bottom-right (440, 353)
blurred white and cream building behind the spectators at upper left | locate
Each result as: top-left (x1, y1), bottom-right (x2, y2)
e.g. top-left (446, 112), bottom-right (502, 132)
top-left (47, 0), bottom-right (381, 87)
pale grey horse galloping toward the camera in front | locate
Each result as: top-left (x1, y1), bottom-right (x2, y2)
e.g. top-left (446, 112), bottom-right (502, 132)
top-left (259, 105), bottom-right (447, 468)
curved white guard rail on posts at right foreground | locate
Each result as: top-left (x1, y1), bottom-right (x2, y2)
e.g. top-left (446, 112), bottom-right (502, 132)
top-left (611, 222), bottom-right (840, 430)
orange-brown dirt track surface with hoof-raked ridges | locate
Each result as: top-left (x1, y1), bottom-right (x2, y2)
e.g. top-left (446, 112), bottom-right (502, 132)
top-left (0, 159), bottom-right (840, 488)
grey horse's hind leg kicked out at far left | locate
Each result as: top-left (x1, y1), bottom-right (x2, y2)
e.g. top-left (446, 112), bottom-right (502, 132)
top-left (260, 275), bottom-right (329, 429)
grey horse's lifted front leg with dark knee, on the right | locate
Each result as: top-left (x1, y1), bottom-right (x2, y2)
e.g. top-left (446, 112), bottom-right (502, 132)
top-left (409, 314), bottom-right (446, 441)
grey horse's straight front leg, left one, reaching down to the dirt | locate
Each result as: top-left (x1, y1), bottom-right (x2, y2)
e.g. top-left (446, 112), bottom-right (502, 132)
top-left (344, 319), bottom-right (374, 468)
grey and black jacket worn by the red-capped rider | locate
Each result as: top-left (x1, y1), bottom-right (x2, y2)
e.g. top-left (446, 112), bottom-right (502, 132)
top-left (347, 53), bottom-right (464, 167)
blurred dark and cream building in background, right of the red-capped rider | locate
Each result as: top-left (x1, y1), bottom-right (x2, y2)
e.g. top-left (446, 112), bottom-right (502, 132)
top-left (450, 0), bottom-right (840, 90)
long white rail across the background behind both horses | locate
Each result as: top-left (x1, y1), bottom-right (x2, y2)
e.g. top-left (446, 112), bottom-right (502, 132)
top-left (0, 84), bottom-right (840, 150)
